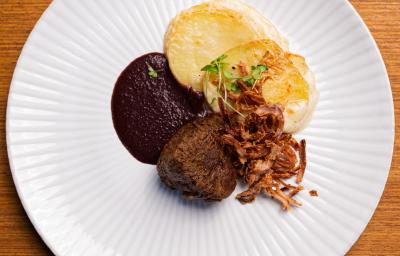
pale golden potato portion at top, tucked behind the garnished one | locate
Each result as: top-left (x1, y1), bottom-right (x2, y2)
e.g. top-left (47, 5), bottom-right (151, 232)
top-left (164, 0), bottom-right (288, 91)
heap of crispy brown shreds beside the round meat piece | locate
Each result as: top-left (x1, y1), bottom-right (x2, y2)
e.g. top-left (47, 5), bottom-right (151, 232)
top-left (219, 100), bottom-right (306, 210)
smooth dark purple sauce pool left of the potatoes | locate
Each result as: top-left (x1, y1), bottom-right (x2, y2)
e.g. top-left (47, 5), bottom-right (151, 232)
top-left (111, 53), bottom-right (207, 164)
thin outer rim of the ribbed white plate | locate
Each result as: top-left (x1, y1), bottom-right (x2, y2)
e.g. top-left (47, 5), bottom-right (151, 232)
top-left (5, 0), bottom-right (396, 255)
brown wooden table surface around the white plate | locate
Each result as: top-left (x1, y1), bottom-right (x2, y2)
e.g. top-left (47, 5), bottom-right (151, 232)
top-left (0, 0), bottom-right (400, 256)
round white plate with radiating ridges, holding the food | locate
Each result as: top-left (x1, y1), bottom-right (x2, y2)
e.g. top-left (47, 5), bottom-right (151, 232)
top-left (7, 0), bottom-right (394, 256)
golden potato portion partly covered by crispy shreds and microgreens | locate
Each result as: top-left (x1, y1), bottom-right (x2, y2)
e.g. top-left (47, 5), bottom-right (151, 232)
top-left (205, 40), bottom-right (318, 133)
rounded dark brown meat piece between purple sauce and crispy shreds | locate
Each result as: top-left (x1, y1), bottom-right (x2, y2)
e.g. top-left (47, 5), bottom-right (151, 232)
top-left (157, 114), bottom-right (236, 201)
